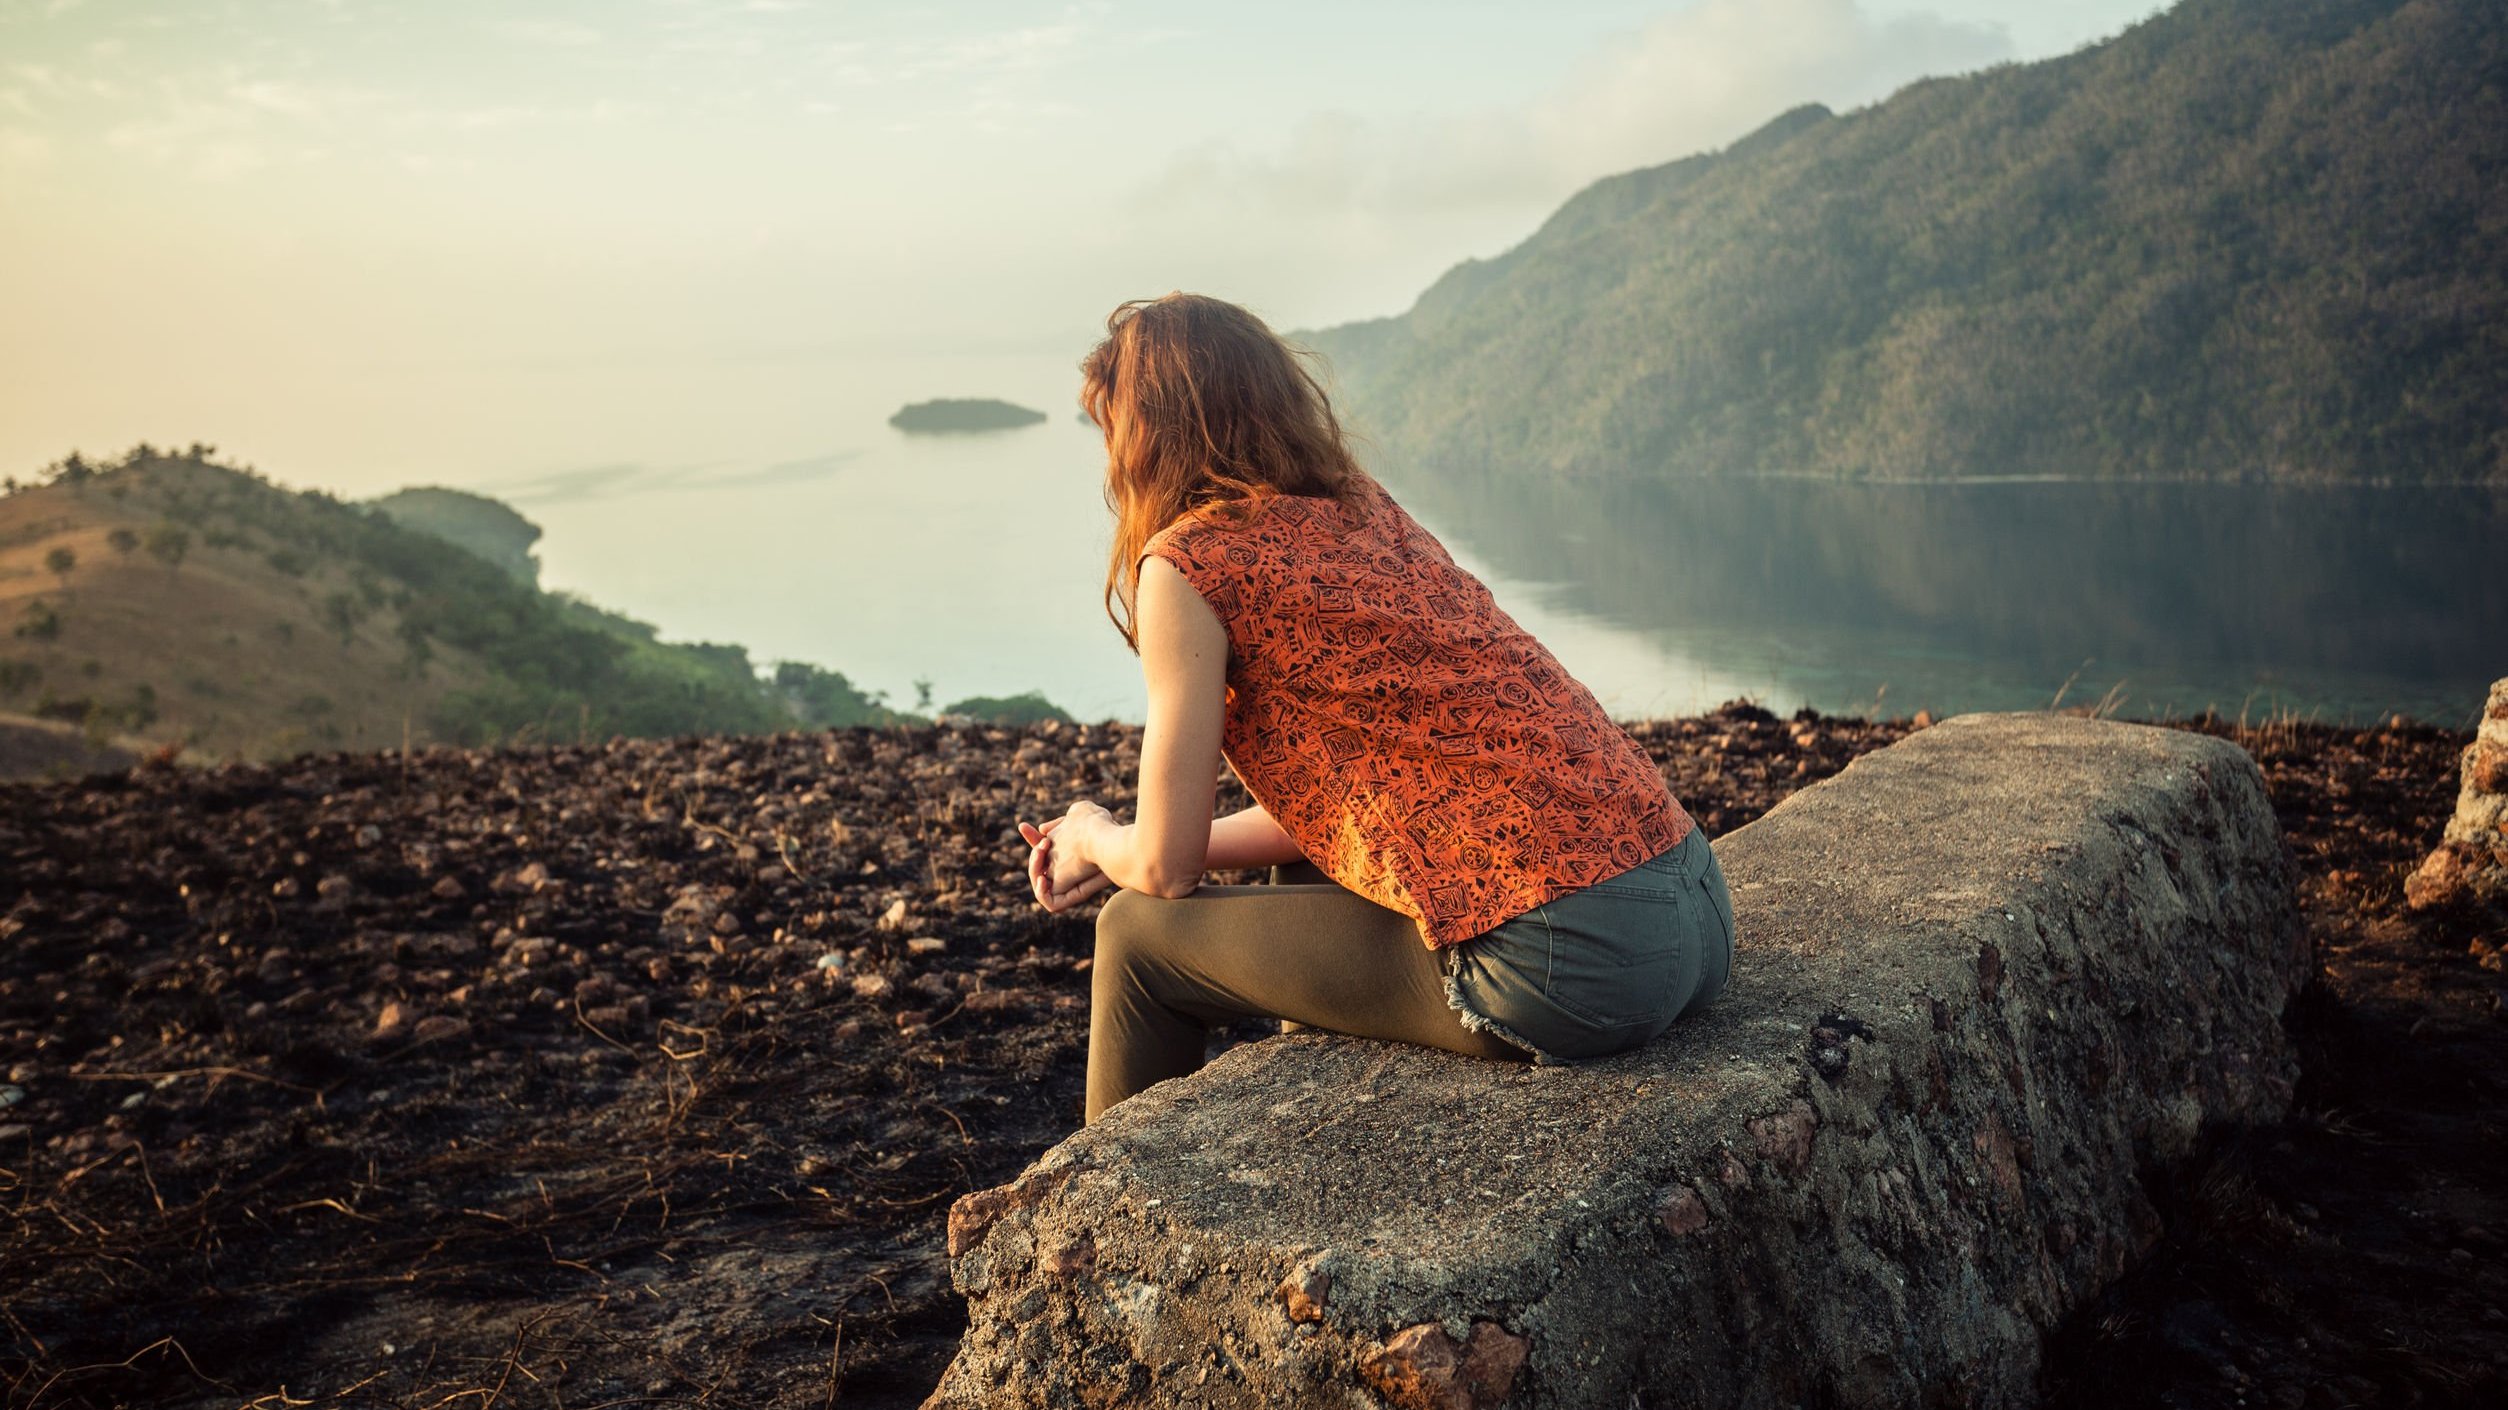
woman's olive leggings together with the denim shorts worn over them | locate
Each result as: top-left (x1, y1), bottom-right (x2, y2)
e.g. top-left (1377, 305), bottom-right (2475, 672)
top-left (1086, 828), bottom-right (1733, 1121)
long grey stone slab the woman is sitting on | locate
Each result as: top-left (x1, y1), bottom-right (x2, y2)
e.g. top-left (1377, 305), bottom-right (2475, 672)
top-left (928, 715), bottom-right (2307, 1410)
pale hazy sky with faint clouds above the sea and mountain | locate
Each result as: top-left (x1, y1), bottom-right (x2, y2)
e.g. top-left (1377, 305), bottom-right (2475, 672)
top-left (0, 0), bottom-right (2154, 494)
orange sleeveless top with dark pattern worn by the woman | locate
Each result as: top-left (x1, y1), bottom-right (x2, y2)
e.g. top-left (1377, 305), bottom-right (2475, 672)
top-left (1144, 476), bottom-right (1690, 948)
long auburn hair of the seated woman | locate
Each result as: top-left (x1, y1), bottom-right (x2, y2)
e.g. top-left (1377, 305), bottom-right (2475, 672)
top-left (1081, 294), bottom-right (1374, 652)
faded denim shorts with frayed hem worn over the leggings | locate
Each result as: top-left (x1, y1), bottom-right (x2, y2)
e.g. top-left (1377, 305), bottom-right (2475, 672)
top-left (1442, 828), bottom-right (1733, 1064)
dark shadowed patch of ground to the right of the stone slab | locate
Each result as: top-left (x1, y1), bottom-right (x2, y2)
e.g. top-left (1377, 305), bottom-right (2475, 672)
top-left (2047, 712), bottom-right (2508, 1410)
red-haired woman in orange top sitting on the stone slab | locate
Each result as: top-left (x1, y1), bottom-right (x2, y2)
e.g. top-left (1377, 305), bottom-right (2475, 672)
top-left (1021, 294), bottom-right (1733, 1121)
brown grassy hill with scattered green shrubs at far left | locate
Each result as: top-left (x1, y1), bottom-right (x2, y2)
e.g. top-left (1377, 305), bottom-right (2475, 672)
top-left (0, 447), bottom-right (905, 760)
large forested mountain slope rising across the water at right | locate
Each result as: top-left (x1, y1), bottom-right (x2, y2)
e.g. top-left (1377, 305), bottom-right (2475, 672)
top-left (1304, 0), bottom-right (2508, 484)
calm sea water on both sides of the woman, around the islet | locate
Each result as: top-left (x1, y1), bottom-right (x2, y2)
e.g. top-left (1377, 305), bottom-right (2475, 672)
top-left (482, 356), bottom-right (2508, 723)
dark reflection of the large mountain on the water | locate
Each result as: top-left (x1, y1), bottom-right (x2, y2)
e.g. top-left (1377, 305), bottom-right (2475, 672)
top-left (1394, 477), bottom-right (2508, 705)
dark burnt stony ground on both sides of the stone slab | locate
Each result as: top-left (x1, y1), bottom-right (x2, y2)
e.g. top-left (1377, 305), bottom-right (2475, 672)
top-left (0, 705), bottom-right (2508, 1410)
